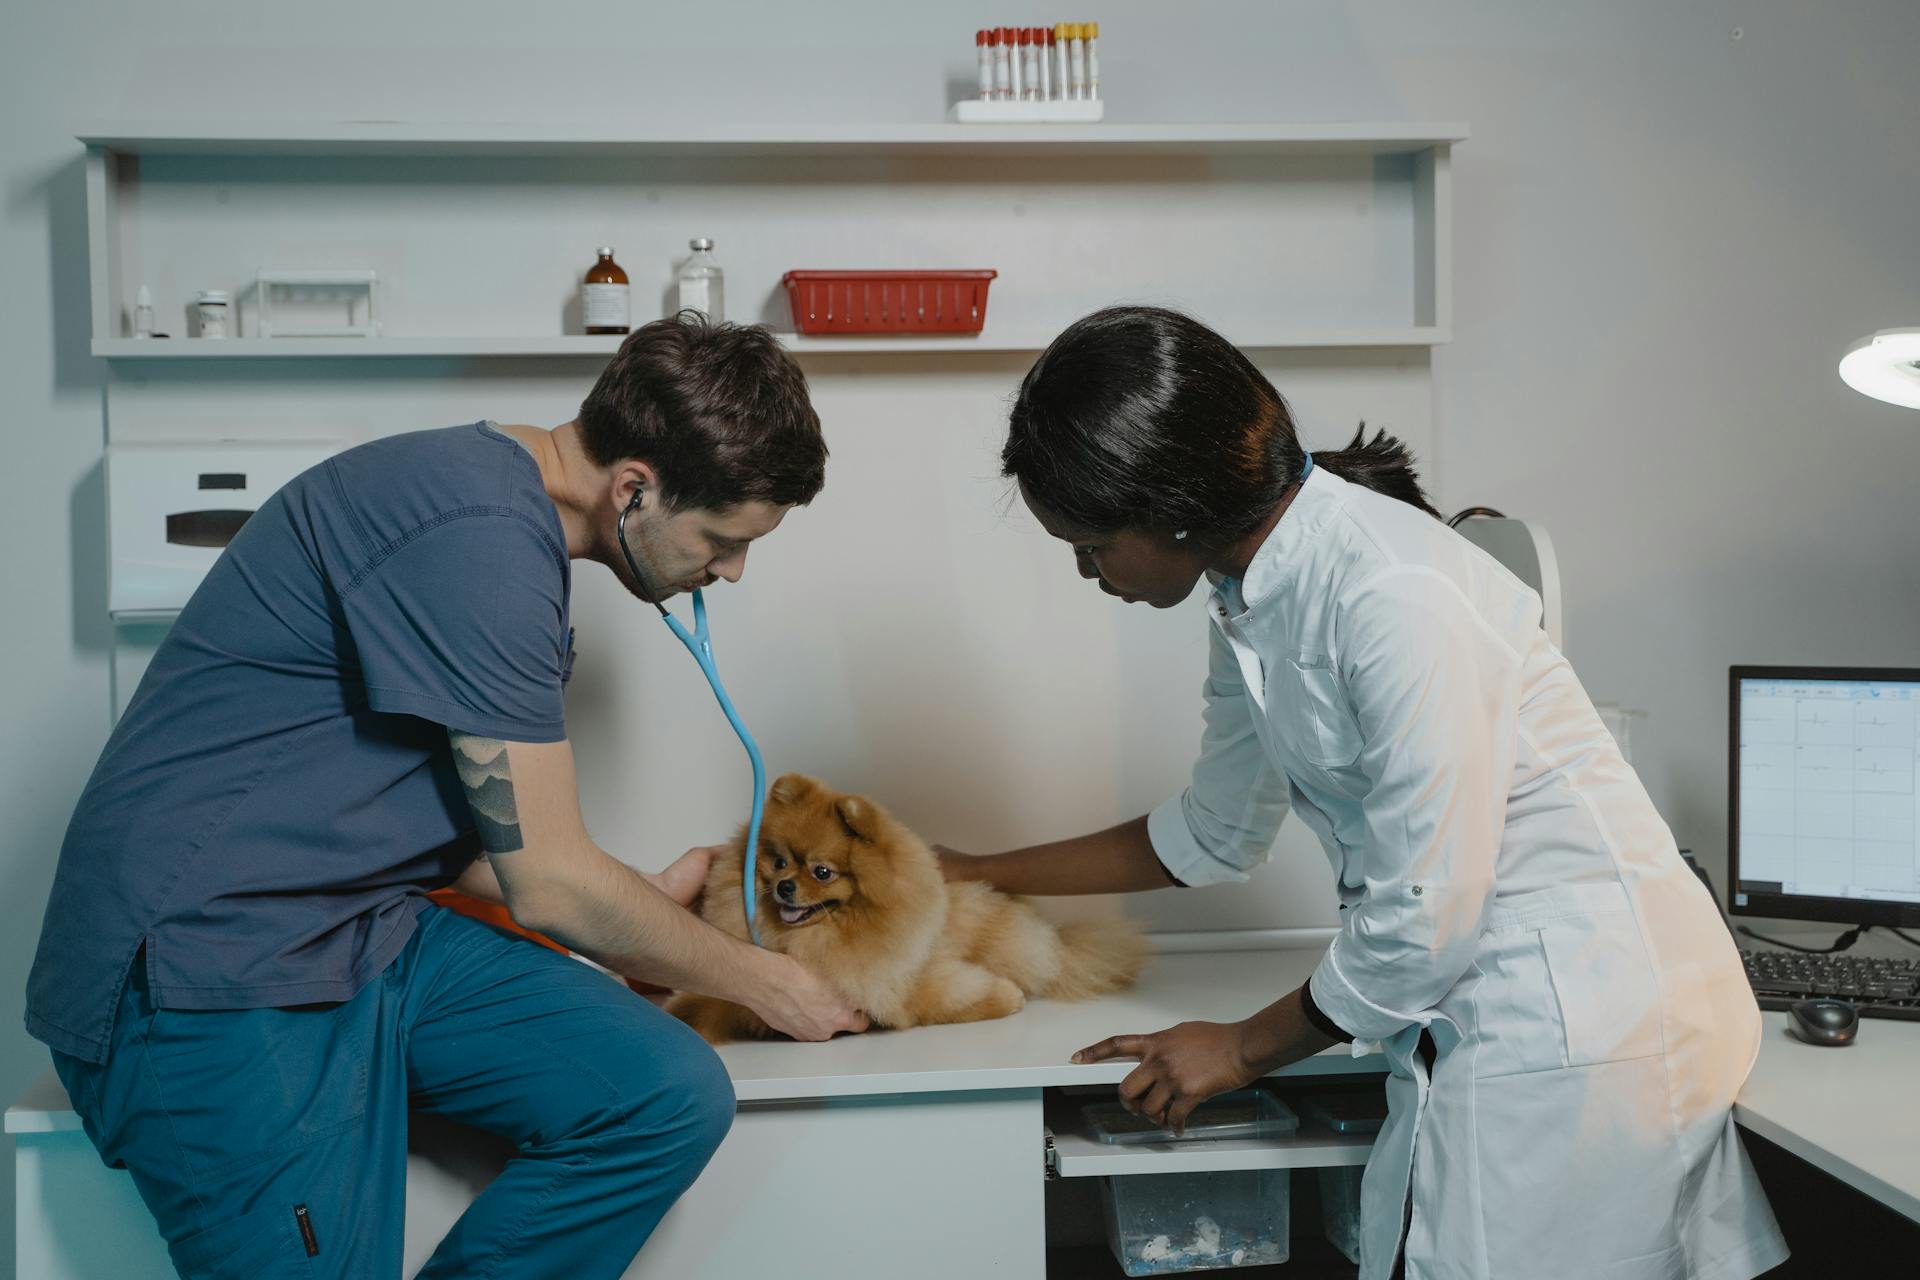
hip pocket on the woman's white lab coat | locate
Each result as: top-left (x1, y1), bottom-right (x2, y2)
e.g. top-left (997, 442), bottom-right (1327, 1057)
top-left (1540, 910), bottom-right (1663, 1067)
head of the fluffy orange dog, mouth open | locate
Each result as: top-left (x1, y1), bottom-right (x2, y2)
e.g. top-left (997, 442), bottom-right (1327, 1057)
top-left (755, 773), bottom-right (887, 929)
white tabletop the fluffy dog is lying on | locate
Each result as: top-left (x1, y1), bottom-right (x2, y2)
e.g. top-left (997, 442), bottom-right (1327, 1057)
top-left (6, 950), bottom-right (1384, 1134)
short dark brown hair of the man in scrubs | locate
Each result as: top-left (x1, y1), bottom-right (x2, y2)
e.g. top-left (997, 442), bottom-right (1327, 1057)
top-left (580, 311), bottom-right (828, 510)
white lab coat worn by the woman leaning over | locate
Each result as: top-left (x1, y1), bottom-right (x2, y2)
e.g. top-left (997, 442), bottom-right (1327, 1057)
top-left (1148, 466), bottom-right (1786, 1280)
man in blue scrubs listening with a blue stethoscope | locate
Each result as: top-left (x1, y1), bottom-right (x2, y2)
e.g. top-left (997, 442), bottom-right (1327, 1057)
top-left (27, 312), bottom-right (864, 1280)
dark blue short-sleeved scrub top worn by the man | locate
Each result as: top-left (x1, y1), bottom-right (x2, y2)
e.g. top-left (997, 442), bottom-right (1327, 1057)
top-left (27, 422), bottom-right (572, 1061)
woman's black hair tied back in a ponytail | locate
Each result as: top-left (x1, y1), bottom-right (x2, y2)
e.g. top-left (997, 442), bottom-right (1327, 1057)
top-left (1000, 307), bottom-right (1440, 545)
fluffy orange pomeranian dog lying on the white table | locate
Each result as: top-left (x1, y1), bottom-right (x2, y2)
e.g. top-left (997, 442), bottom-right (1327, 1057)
top-left (666, 773), bottom-right (1148, 1044)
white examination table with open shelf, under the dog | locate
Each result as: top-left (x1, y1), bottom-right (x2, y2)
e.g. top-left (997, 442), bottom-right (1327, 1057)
top-left (8, 950), bottom-right (1384, 1280)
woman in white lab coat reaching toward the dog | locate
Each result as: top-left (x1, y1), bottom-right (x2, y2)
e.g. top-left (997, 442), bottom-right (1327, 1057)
top-left (945, 307), bottom-right (1786, 1280)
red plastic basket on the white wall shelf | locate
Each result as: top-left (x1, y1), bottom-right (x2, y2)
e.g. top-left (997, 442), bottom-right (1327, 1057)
top-left (781, 271), bottom-right (1000, 334)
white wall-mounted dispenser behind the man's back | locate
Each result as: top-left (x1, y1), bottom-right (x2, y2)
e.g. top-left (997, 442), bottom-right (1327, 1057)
top-left (106, 441), bottom-right (346, 622)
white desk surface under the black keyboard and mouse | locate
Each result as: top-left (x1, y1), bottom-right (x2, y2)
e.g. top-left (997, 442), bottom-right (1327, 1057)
top-left (1734, 1013), bottom-right (1920, 1221)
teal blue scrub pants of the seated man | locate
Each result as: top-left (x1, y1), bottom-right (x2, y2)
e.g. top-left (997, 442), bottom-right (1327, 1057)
top-left (54, 908), bottom-right (733, 1280)
